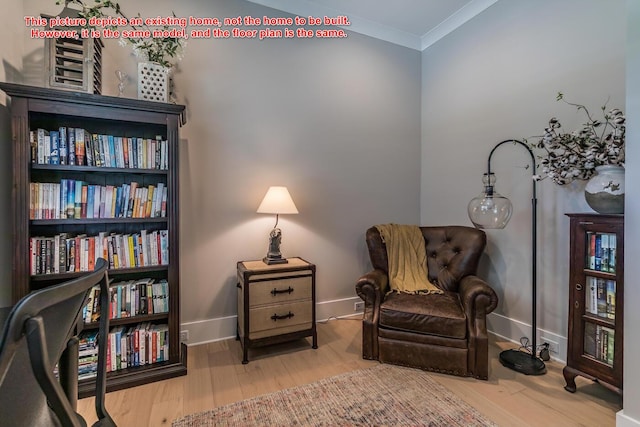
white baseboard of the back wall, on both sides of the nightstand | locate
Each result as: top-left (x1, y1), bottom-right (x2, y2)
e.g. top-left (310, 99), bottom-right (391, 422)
top-left (180, 297), bottom-right (362, 346)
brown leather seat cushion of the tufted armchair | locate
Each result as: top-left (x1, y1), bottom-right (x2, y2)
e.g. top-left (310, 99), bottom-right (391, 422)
top-left (379, 292), bottom-right (467, 339)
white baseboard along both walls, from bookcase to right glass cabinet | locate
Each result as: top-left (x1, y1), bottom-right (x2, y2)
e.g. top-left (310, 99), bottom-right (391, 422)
top-left (180, 297), bottom-right (567, 362)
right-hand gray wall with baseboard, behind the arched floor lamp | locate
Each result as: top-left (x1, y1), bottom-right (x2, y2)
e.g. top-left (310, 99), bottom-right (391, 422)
top-left (421, 0), bottom-right (626, 358)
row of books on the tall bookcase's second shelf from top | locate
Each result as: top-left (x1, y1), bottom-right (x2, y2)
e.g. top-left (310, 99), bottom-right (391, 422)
top-left (29, 179), bottom-right (167, 219)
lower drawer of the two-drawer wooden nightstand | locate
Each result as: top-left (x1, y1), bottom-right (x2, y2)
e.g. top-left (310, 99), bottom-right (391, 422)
top-left (249, 300), bottom-right (313, 339)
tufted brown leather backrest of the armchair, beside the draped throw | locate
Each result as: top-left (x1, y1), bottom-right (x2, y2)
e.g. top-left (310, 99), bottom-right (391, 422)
top-left (366, 225), bottom-right (487, 292)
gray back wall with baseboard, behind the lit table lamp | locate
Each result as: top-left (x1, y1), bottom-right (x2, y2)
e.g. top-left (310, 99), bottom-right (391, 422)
top-left (17, 0), bottom-right (420, 342)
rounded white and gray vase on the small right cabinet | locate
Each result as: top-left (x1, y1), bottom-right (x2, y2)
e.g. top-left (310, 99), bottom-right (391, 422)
top-left (584, 165), bottom-right (624, 214)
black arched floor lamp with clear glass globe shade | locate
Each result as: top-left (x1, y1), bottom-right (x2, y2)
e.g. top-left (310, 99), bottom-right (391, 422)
top-left (467, 139), bottom-right (547, 375)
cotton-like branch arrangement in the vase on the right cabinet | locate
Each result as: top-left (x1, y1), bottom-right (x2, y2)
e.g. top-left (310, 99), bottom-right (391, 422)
top-left (530, 92), bottom-right (625, 185)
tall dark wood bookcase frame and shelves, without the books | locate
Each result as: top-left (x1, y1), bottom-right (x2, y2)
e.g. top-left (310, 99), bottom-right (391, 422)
top-left (0, 83), bottom-right (187, 397)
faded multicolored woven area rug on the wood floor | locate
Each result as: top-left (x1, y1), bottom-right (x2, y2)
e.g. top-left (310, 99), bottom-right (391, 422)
top-left (172, 364), bottom-right (495, 427)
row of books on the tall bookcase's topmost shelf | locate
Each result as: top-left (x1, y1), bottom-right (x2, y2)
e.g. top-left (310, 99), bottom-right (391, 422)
top-left (29, 126), bottom-right (169, 170)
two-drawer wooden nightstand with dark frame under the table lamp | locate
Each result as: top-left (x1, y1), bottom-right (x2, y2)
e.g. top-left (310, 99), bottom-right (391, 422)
top-left (237, 258), bottom-right (318, 364)
